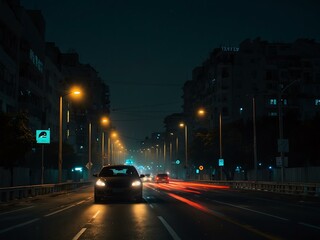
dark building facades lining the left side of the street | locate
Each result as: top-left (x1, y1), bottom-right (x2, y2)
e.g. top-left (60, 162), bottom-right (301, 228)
top-left (0, 0), bottom-right (110, 183)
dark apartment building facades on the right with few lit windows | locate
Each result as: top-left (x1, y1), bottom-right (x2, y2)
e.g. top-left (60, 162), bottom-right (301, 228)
top-left (183, 39), bottom-right (320, 128)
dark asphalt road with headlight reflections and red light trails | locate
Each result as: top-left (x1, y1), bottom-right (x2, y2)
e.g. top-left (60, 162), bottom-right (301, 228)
top-left (0, 181), bottom-right (320, 240)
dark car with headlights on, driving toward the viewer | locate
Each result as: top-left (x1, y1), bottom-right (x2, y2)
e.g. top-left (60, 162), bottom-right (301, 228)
top-left (94, 165), bottom-right (144, 203)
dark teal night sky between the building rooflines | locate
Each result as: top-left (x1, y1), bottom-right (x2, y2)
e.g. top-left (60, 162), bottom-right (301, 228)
top-left (21, 0), bottom-right (320, 147)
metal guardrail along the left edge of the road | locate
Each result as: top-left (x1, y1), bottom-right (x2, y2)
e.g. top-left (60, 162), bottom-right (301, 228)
top-left (0, 182), bottom-right (91, 202)
